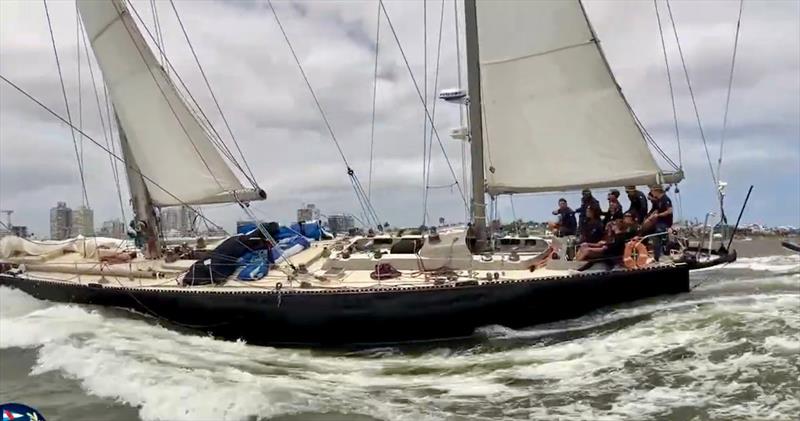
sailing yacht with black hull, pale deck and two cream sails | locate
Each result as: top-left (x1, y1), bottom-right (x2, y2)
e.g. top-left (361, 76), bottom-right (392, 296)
top-left (0, 0), bottom-right (736, 346)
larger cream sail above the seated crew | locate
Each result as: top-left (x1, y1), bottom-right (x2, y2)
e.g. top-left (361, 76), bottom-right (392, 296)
top-left (476, 0), bottom-right (660, 194)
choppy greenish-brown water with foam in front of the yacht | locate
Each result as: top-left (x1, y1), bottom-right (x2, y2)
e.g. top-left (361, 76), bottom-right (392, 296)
top-left (0, 251), bottom-right (800, 421)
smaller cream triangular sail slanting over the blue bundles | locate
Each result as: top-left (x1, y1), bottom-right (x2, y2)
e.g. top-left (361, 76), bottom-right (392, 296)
top-left (78, 0), bottom-right (253, 206)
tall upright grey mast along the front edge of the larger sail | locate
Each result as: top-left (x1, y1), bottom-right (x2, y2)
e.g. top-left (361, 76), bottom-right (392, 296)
top-left (464, 0), bottom-right (487, 251)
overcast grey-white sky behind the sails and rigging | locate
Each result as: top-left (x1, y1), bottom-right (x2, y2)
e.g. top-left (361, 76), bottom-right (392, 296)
top-left (0, 0), bottom-right (800, 237)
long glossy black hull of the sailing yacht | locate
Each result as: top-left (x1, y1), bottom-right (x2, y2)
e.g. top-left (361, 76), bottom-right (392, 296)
top-left (0, 264), bottom-right (689, 346)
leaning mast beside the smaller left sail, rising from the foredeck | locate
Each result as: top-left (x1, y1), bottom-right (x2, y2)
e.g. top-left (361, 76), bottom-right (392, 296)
top-left (114, 113), bottom-right (161, 259)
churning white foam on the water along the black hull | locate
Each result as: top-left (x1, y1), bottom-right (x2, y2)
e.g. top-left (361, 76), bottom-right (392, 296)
top-left (0, 276), bottom-right (800, 421)
